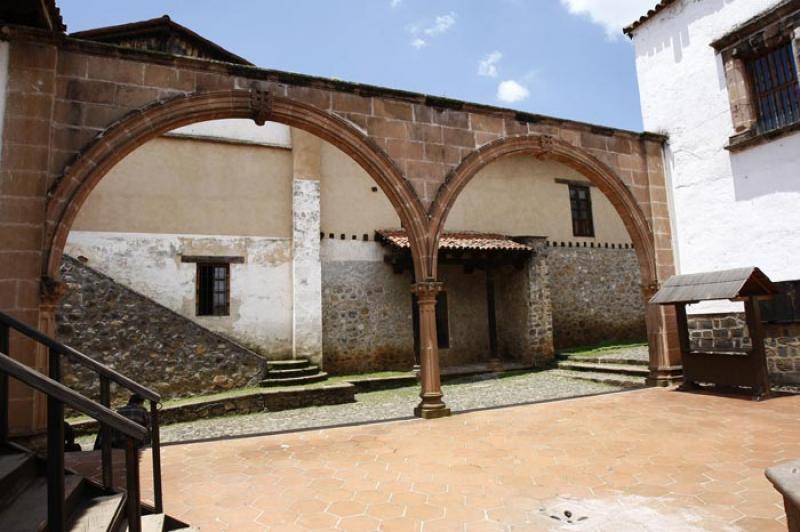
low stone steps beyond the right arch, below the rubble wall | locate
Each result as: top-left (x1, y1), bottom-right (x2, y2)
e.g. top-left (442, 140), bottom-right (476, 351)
top-left (555, 353), bottom-right (649, 388)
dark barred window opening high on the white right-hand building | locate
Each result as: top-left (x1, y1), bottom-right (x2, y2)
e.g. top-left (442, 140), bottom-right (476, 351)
top-left (750, 42), bottom-right (800, 132)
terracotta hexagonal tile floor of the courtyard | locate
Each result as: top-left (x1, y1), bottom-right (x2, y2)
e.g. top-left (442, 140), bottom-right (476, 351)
top-left (69, 389), bottom-right (800, 532)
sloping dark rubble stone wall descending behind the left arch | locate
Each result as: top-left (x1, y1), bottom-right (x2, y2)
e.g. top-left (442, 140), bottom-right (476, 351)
top-left (57, 256), bottom-right (265, 400)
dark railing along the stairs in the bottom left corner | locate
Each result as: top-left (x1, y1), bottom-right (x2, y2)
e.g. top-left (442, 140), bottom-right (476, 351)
top-left (0, 312), bottom-right (164, 532)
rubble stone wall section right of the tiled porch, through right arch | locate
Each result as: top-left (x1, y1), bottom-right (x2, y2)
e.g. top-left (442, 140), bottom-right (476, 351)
top-left (547, 243), bottom-right (647, 349)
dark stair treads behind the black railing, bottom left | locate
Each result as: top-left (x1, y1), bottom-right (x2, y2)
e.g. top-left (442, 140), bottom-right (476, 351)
top-left (0, 443), bottom-right (196, 532)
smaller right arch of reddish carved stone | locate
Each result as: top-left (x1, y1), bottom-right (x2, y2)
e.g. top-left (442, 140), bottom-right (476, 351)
top-left (427, 135), bottom-right (657, 288)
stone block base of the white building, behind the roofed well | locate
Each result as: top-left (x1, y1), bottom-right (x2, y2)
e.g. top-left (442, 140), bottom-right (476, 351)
top-left (688, 313), bottom-right (800, 385)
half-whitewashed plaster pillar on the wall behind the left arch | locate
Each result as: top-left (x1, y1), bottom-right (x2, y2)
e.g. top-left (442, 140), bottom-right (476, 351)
top-left (292, 130), bottom-right (322, 367)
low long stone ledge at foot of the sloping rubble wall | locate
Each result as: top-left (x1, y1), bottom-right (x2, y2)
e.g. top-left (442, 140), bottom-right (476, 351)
top-left (72, 383), bottom-right (356, 436)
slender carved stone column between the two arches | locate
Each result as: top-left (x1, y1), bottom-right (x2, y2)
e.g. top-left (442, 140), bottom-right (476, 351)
top-left (411, 281), bottom-right (450, 419)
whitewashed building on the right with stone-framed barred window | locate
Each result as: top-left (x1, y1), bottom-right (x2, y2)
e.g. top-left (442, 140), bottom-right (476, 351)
top-left (626, 0), bottom-right (800, 384)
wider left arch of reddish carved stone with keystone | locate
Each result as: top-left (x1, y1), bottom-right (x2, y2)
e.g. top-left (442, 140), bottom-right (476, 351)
top-left (43, 89), bottom-right (427, 279)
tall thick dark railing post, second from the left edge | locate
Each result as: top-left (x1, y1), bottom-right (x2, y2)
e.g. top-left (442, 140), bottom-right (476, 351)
top-left (47, 349), bottom-right (66, 532)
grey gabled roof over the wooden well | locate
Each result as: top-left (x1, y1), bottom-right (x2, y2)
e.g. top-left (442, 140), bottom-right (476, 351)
top-left (650, 267), bottom-right (778, 305)
